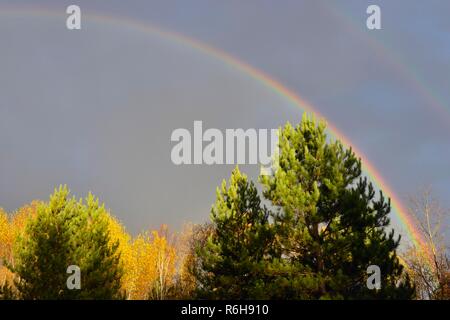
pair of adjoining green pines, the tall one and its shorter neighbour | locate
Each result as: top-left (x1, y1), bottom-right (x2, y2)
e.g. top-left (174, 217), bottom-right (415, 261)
top-left (197, 116), bottom-right (414, 299)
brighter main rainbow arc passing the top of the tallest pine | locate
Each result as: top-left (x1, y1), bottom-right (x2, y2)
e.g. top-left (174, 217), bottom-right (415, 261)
top-left (0, 7), bottom-right (427, 258)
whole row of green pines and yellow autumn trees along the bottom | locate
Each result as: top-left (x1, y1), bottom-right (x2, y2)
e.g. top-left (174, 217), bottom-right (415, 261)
top-left (0, 116), bottom-right (450, 299)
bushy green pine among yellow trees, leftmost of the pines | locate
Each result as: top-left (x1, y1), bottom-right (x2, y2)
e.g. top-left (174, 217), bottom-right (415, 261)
top-left (13, 187), bottom-right (122, 300)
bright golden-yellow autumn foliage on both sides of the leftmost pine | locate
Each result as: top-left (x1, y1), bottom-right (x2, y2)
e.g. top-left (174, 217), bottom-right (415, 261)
top-left (0, 195), bottom-right (188, 300)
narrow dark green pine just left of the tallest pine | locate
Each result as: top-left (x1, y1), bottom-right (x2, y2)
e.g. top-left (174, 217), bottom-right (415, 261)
top-left (197, 167), bottom-right (273, 299)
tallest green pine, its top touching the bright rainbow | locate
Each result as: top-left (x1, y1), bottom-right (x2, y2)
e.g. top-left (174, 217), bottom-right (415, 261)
top-left (261, 116), bottom-right (413, 299)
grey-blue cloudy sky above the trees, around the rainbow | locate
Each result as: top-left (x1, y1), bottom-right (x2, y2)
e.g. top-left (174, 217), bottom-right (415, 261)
top-left (0, 0), bottom-right (450, 240)
